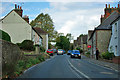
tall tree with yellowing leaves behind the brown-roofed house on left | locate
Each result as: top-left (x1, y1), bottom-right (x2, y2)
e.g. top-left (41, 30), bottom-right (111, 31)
top-left (30, 13), bottom-right (57, 41)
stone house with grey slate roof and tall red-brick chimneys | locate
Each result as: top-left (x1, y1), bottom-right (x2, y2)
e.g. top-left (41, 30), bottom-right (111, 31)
top-left (89, 4), bottom-right (120, 57)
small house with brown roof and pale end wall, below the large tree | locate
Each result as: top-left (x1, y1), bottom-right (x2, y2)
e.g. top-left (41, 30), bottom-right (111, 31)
top-left (33, 27), bottom-right (48, 50)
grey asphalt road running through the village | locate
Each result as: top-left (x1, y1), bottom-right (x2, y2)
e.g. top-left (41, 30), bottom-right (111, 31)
top-left (20, 54), bottom-right (118, 80)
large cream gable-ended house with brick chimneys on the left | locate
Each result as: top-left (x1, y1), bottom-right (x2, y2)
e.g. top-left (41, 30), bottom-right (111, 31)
top-left (0, 5), bottom-right (32, 43)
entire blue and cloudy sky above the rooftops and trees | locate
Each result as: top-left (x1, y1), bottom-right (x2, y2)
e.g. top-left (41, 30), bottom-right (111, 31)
top-left (0, 0), bottom-right (119, 39)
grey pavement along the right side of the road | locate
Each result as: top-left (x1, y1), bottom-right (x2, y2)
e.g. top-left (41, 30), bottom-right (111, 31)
top-left (82, 55), bottom-right (120, 72)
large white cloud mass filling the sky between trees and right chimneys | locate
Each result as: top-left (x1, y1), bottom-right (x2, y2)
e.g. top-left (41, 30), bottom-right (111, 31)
top-left (41, 2), bottom-right (105, 39)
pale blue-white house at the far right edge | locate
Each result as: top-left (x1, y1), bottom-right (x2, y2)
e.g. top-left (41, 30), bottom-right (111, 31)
top-left (108, 12), bottom-right (120, 56)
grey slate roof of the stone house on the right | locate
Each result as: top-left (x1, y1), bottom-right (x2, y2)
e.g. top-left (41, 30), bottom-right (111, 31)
top-left (89, 11), bottom-right (120, 40)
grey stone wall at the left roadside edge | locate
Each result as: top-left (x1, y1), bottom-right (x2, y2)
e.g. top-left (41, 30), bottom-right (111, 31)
top-left (0, 40), bottom-right (22, 78)
